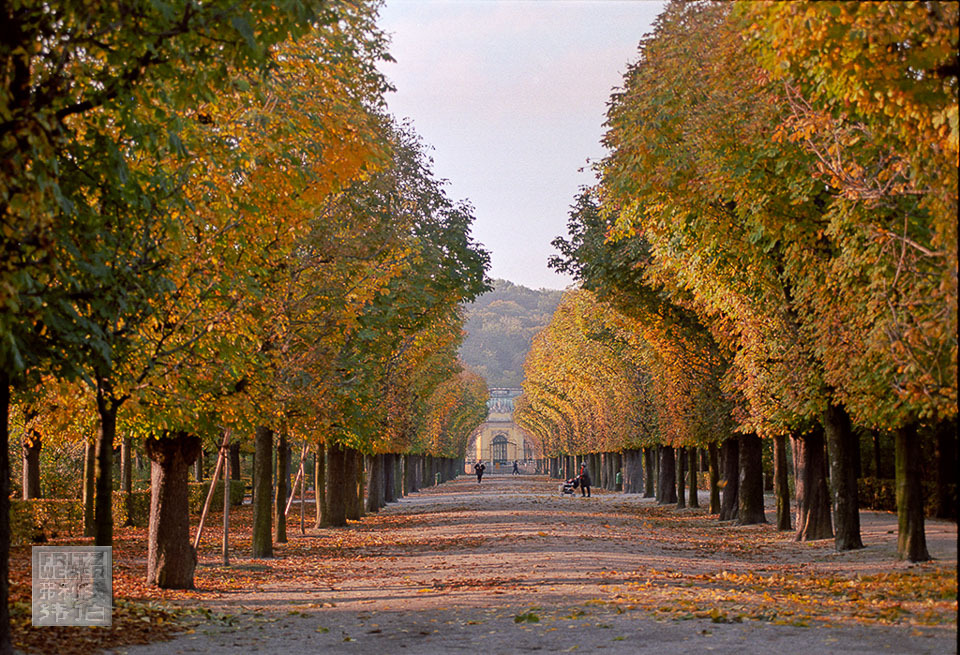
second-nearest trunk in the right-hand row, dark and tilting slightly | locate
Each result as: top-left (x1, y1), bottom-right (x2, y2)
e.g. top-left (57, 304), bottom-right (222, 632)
top-left (823, 404), bottom-right (863, 551)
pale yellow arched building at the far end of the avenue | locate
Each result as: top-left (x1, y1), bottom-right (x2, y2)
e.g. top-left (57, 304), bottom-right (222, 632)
top-left (467, 389), bottom-right (542, 472)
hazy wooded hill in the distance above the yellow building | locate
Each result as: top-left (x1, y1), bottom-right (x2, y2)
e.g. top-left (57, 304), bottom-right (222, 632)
top-left (460, 280), bottom-right (563, 387)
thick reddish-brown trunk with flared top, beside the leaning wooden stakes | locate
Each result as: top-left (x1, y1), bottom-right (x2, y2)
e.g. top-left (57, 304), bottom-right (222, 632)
top-left (144, 432), bottom-right (201, 589)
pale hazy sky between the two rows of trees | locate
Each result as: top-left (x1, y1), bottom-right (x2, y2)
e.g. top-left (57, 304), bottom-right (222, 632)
top-left (379, 0), bottom-right (664, 289)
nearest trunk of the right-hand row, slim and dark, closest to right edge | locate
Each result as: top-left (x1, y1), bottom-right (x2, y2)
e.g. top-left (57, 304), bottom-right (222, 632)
top-left (894, 424), bottom-right (930, 562)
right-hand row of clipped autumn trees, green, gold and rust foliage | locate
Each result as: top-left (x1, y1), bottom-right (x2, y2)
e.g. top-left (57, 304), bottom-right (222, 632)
top-left (520, 2), bottom-right (958, 561)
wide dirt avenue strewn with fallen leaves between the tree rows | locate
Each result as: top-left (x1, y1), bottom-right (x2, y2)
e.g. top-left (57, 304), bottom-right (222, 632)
top-left (107, 475), bottom-right (957, 655)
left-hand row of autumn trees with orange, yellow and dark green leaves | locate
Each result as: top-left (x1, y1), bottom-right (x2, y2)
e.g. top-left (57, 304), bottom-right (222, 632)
top-left (0, 0), bottom-right (489, 653)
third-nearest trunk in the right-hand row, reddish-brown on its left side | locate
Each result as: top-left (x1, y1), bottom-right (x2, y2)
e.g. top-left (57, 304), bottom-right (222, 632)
top-left (793, 429), bottom-right (833, 541)
